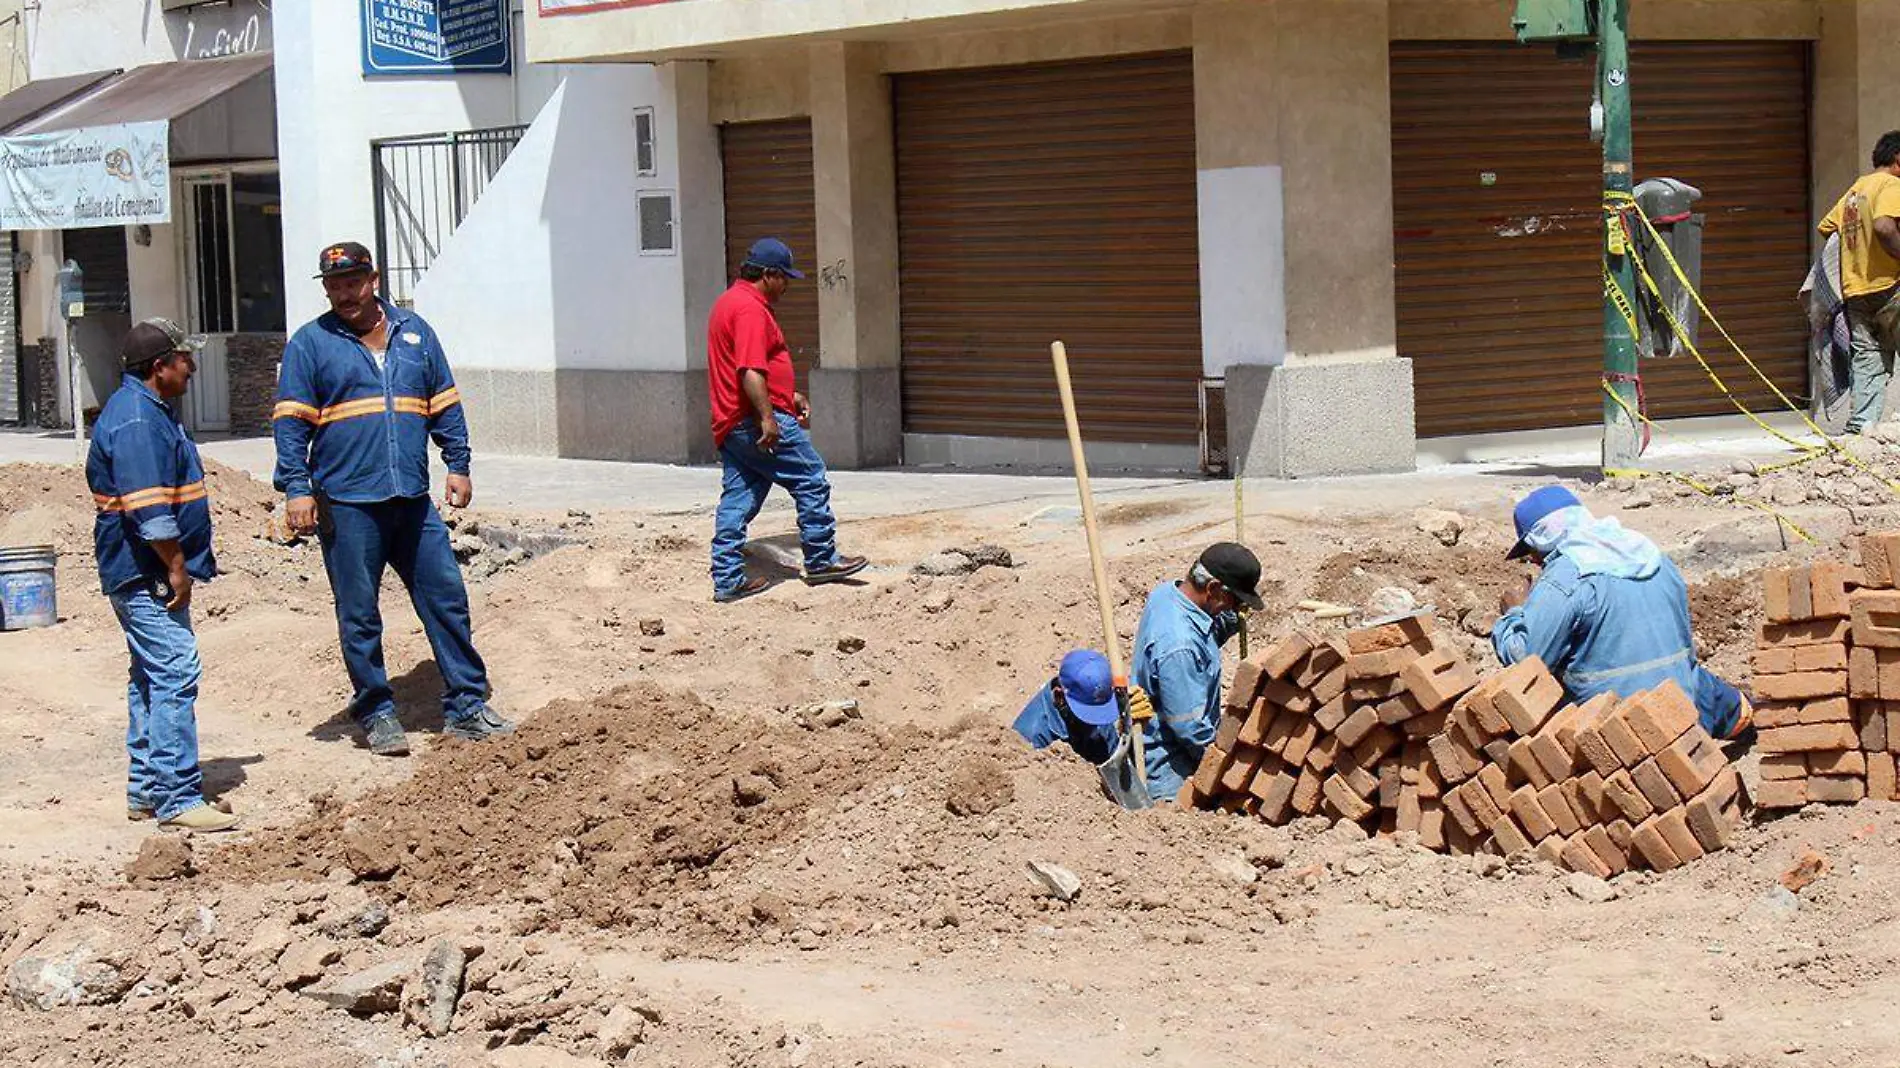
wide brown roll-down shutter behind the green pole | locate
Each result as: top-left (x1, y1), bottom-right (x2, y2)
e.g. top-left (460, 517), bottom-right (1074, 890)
top-left (1398, 42), bottom-right (1809, 437)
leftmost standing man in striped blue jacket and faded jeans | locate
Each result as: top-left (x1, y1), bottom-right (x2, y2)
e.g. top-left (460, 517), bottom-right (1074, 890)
top-left (86, 319), bottom-right (238, 830)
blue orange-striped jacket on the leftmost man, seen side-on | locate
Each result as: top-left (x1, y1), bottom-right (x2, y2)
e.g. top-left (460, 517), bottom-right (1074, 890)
top-left (86, 374), bottom-right (219, 593)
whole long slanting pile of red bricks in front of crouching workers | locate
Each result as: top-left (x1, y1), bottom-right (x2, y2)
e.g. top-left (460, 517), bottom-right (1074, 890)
top-left (1180, 618), bottom-right (1748, 878)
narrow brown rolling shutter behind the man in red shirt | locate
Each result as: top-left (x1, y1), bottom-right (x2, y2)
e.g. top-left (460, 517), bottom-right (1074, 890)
top-left (720, 118), bottom-right (819, 378)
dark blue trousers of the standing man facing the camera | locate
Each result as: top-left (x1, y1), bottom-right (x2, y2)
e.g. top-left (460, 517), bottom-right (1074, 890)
top-left (319, 496), bottom-right (488, 726)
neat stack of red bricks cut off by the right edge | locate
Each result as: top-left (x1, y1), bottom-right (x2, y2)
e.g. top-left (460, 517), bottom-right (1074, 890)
top-left (1754, 534), bottom-right (1900, 808)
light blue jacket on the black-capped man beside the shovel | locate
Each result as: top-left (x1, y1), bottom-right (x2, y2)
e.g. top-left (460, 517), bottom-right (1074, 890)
top-left (1132, 582), bottom-right (1239, 802)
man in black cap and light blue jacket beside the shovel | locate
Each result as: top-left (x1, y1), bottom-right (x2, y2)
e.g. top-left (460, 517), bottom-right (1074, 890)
top-left (1132, 542), bottom-right (1262, 802)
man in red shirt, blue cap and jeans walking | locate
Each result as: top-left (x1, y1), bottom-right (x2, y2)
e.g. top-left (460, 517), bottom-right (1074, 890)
top-left (707, 238), bottom-right (868, 604)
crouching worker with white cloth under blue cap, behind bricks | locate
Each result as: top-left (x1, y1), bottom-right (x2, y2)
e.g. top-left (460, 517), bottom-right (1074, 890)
top-left (1492, 486), bottom-right (1752, 739)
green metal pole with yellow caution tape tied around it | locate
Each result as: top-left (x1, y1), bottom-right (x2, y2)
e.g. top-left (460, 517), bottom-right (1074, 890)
top-left (1598, 0), bottom-right (1642, 469)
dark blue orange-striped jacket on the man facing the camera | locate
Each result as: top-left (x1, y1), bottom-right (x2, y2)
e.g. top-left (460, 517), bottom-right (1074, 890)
top-left (272, 296), bottom-right (469, 504)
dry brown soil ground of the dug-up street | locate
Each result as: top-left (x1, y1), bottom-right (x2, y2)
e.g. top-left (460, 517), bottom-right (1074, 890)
top-left (0, 450), bottom-right (1900, 1068)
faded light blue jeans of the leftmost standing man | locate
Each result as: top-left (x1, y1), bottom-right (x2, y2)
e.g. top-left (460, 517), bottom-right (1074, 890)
top-left (112, 583), bottom-right (205, 819)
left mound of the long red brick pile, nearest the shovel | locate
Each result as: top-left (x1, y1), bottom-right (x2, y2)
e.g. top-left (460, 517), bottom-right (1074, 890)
top-left (1180, 616), bottom-right (1478, 836)
